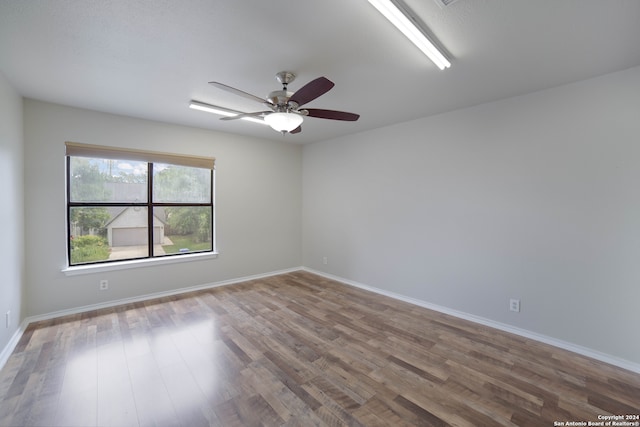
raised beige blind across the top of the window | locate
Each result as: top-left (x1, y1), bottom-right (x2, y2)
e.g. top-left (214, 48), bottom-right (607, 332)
top-left (65, 142), bottom-right (215, 169)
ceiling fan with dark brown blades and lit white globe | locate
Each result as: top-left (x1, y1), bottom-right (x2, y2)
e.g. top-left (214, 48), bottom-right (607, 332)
top-left (209, 71), bottom-right (360, 134)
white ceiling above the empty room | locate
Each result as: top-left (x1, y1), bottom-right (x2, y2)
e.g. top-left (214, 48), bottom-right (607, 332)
top-left (0, 0), bottom-right (640, 143)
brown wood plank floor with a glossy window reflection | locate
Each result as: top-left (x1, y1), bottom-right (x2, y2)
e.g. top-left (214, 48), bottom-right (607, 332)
top-left (0, 272), bottom-right (640, 427)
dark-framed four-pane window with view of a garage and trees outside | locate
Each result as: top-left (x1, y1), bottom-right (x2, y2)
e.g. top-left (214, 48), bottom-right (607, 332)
top-left (66, 142), bottom-right (215, 266)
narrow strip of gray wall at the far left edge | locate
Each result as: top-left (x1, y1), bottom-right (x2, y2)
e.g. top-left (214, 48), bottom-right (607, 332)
top-left (0, 73), bottom-right (25, 354)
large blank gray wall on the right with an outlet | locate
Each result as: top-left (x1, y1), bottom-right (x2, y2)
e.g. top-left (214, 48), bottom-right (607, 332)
top-left (303, 68), bottom-right (640, 363)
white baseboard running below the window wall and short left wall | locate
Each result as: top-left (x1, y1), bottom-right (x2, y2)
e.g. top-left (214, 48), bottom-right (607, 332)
top-left (0, 267), bottom-right (302, 369)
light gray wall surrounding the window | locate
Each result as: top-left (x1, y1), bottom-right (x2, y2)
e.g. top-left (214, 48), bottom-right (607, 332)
top-left (24, 100), bottom-right (302, 316)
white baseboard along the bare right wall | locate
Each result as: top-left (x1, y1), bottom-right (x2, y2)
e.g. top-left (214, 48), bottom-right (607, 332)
top-left (302, 267), bottom-right (640, 374)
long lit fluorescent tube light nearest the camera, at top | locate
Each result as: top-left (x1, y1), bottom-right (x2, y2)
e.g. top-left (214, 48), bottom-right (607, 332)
top-left (368, 0), bottom-right (451, 70)
